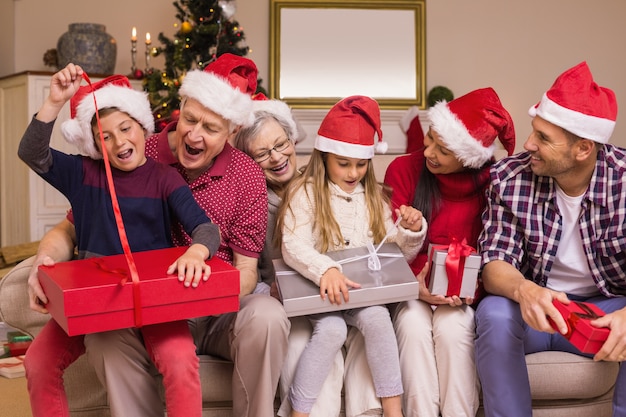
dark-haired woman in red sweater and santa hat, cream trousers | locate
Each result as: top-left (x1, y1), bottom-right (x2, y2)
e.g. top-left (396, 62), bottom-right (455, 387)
top-left (385, 88), bottom-right (515, 417)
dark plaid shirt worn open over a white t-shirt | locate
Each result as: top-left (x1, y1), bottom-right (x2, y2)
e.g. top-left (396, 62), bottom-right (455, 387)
top-left (479, 145), bottom-right (626, 297)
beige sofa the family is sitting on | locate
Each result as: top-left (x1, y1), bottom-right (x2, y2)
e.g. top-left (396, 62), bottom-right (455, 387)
top-left (0, 257), bottom-right (619, 417)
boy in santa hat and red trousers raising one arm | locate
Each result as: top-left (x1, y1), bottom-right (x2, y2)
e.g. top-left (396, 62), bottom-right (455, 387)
top-left (18, 64), bottom-right (220, 417)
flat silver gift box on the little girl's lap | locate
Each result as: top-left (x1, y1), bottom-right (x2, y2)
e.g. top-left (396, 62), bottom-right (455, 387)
top-left (274, 243), bottom-right (419, 317)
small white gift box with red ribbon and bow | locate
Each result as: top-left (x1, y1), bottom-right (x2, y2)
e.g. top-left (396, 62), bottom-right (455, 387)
top-left (427, 241), bottom-right (480, 298)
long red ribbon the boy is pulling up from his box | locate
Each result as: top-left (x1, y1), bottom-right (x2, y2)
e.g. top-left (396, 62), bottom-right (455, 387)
top-left (83, 72), bottom-right (142, 327)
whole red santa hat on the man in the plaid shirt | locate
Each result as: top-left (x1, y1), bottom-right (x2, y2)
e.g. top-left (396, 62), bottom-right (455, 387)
top-left (528, 62), bottom-right (617, 143)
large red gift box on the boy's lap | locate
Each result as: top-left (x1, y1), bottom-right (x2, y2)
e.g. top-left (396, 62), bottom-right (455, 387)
top-left (39, 247), bottom-right (240, 317)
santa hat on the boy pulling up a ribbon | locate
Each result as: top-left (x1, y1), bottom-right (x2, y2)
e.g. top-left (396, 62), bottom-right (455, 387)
top-left (61, 75), bottom-right (154, 159)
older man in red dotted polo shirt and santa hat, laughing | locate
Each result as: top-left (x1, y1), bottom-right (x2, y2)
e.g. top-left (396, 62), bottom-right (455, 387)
top-left (30, 54), bottom-right (289, 417)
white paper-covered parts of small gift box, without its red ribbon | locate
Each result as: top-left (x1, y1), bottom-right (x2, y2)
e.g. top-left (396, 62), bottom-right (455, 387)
top-left (428, 244), bottom-right (480, 298)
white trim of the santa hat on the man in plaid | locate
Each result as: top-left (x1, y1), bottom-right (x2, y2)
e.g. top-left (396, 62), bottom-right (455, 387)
top-left (528, 93), bottom-right (615, 143)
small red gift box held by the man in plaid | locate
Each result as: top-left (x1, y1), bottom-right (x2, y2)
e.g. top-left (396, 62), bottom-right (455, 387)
top-left (548, 300), bottom-right (610, 354)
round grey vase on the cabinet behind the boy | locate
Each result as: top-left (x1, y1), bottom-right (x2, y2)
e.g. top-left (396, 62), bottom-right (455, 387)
top-left (57, 23), bottom-right (117, 75)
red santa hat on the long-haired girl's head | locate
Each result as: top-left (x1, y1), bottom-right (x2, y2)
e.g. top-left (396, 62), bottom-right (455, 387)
top-left (315, 96), bottom-right (387, 159)
